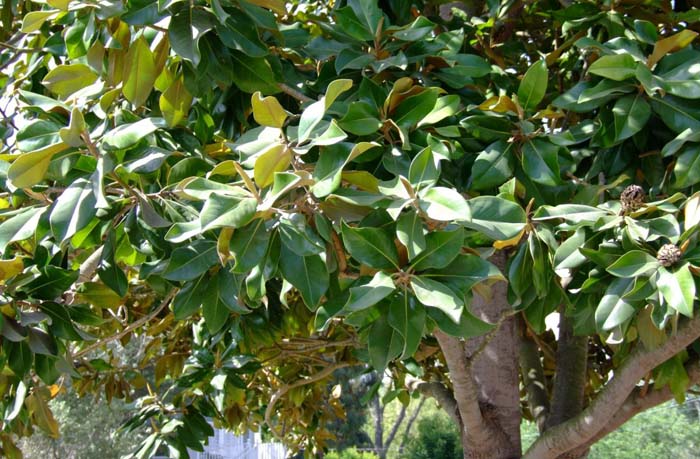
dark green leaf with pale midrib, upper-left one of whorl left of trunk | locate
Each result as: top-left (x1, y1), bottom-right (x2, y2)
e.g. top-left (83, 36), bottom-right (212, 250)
top-left (342, 223), bottom-right (399, 269)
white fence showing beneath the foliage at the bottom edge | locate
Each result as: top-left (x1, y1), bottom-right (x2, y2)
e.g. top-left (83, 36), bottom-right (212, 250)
top-left (190, 429), bottom-right (287, 459)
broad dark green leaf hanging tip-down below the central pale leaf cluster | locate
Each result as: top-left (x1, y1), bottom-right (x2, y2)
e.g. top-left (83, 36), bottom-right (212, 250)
top-left (280, 245), bottom-right (329, 311)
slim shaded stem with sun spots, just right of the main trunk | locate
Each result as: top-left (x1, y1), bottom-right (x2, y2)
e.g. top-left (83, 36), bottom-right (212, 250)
top-left (520, 328), bottom-right (549, 432)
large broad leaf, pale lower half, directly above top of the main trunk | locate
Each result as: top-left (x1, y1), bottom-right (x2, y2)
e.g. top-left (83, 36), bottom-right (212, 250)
top-left (461, 196), bottom-right (527, 241)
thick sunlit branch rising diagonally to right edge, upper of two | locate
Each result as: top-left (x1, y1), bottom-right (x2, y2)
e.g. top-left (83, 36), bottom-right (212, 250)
top-left (523, 316), bottom-right (700, 459)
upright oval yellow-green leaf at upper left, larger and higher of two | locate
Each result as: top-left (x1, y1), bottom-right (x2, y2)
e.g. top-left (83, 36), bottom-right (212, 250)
top-left (122, 36), bottom-right (158, 107)
